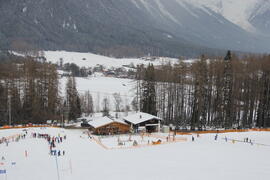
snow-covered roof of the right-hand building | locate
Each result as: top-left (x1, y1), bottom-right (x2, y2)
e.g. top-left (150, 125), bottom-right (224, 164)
top-left (124, 112), bottom-right (162, 124)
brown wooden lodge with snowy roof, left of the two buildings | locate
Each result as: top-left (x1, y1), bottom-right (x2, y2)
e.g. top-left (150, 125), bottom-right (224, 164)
top-left (88, 116), bottom-right (130, 135)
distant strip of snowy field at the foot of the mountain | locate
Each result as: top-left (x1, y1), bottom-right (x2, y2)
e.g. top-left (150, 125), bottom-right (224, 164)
top-left (44, 51), bottom-right (178, 67)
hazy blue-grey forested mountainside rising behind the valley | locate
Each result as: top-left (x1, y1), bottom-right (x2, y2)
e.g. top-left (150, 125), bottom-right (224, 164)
top-left (0, 0), bottom-right (270, 56)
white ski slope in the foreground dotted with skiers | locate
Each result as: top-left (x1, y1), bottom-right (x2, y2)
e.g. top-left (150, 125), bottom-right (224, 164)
top-left (0, 128), bottom-right (270, 180)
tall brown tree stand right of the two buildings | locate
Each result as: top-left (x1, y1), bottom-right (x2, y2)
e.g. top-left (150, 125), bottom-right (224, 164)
top-left (136, 51), bottom-right (270, 130)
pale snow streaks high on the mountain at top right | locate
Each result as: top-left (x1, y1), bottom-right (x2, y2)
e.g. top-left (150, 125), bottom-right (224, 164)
top-left (131, 0), bottom-right (264, 32)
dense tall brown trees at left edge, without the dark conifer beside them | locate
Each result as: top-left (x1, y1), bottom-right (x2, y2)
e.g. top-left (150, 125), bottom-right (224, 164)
top-left (0, 57), bottom-right (60, 125)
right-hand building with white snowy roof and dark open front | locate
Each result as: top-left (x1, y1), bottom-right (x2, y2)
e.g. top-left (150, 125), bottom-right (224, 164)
top-left (123, 112), bottom-right (162, 132)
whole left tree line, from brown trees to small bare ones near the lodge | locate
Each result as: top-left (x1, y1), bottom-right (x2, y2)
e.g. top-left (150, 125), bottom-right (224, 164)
top-left (0, 55), bottom-right (129, 125)
